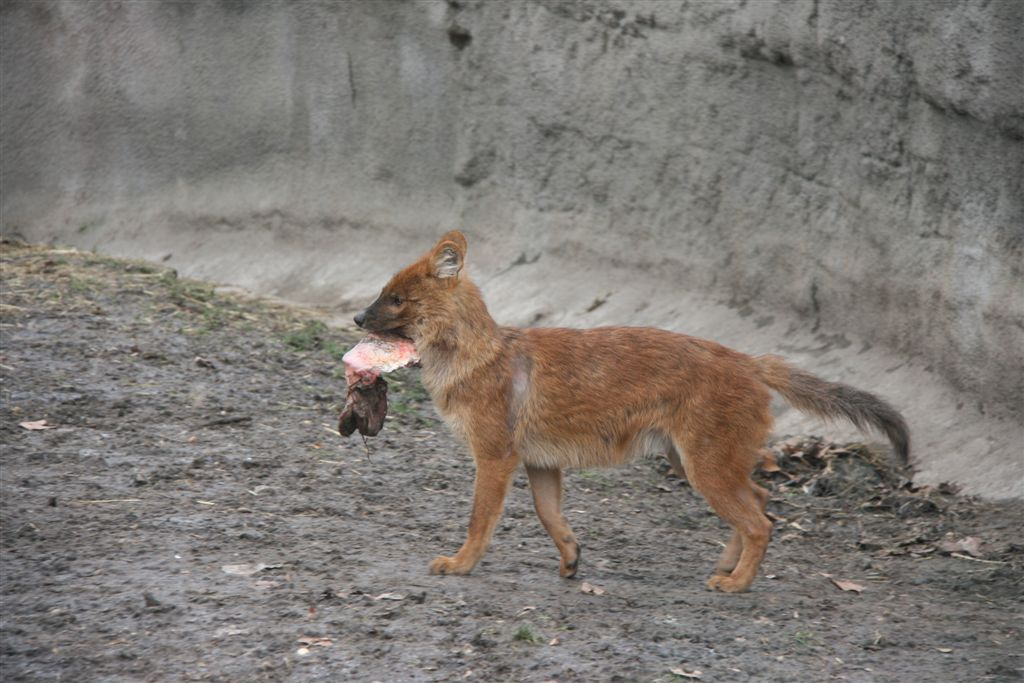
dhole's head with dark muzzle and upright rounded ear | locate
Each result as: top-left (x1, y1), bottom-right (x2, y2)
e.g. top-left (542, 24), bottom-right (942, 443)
top-left (354, 230), bottom-right (467, 341)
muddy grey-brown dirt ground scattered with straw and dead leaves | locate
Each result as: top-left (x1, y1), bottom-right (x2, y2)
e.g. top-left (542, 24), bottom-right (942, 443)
top-left (0, 243), bottom-right (1024, 681)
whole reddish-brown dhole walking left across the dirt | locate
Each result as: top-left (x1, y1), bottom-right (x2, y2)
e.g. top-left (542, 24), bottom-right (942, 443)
top-left (355, 231), bottom-right (909, 592)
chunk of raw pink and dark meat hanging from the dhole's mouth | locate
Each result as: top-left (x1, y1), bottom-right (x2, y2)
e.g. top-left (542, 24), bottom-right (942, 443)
top-left (338, 333), bottom-right (420, 436)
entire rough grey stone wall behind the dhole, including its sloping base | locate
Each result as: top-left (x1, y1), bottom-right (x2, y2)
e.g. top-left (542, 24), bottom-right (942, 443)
top-left (0, 0), bottom-right (1024, 491)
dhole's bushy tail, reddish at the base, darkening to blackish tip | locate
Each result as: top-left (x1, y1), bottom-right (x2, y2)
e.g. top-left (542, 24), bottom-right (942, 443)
top-left (754, 355), bottom-right (910, 465)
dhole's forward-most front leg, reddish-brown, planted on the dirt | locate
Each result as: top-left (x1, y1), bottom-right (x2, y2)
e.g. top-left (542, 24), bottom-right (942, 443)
top-left (430, 451), bottom-right (519, 574)
